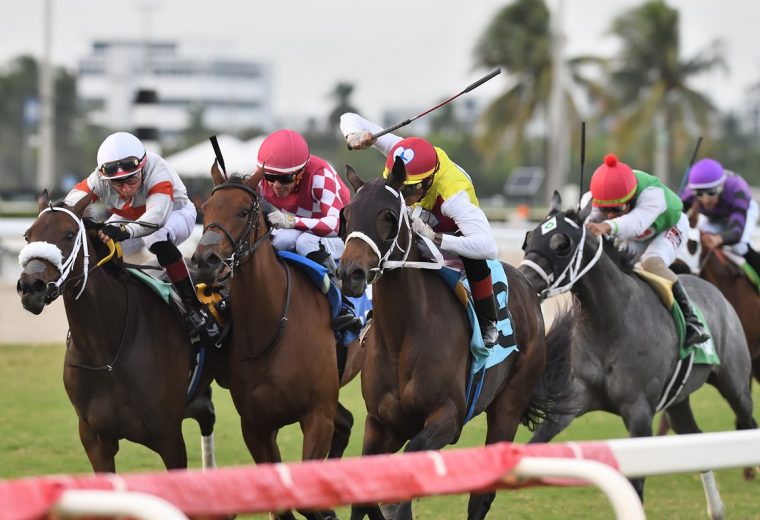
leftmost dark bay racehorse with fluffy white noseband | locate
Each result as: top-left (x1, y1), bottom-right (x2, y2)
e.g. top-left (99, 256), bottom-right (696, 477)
top-left (17, 192), bottom-right (220, 472)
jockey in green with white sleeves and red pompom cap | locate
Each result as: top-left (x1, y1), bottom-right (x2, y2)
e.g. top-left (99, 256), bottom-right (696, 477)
top-left (586, 154), bottom-right (709, 346)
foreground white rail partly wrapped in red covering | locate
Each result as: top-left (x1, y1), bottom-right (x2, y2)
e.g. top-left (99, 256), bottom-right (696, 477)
top-left (0, 430), bottom-right (760, 520)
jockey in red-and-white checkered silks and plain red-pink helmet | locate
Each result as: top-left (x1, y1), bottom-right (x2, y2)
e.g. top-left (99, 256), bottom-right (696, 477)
top-left (257, 130), bottom-right (361, 333)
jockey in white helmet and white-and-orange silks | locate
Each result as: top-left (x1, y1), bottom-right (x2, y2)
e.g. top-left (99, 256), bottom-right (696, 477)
top-left (65, 132), bottom-right (220, 344)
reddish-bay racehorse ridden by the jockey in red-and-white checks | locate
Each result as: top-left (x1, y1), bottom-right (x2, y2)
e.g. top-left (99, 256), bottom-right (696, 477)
top-left (192, 164), bottom-right (363, 518)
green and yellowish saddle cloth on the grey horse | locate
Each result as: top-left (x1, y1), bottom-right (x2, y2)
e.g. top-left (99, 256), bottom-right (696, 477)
top-left (634, 267), bottom-right (720, 365)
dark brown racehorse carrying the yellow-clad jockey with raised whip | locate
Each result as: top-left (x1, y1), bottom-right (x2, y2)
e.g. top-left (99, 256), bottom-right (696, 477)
top-left (338, 159), bottom-right (571, 520)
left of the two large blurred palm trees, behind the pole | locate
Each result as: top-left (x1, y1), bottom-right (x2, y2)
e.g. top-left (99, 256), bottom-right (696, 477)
top-left (475, 0), bottom-right (604, 189)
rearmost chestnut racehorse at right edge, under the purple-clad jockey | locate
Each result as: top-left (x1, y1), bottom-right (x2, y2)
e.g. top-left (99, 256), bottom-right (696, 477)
top-left (674, 219), bottom-right (760, 382)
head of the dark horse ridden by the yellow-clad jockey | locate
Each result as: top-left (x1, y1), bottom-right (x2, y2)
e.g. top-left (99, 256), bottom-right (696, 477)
top-left (338, 157), bottom-right (411, 296)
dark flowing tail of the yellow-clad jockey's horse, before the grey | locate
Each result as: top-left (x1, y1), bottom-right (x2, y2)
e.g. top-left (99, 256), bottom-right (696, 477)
top-left (520, 305), bottom-right (576, 431)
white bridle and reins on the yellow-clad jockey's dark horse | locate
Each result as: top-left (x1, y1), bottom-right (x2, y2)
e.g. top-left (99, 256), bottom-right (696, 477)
top-left (346, 184), bottom-right (443, 285)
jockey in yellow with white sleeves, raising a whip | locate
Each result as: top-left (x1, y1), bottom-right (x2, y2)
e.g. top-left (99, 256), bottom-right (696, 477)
top-left (340, 112), bottom-right (499, 348)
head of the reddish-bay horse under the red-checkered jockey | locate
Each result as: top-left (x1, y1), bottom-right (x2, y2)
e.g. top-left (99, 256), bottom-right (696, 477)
top-left (192, 162), bottom-right (266, 284)
